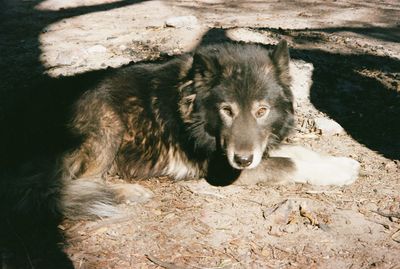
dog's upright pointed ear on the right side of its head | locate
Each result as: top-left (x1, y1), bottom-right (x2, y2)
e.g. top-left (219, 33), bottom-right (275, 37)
top-left (270, 40), bottom-right (290, 83)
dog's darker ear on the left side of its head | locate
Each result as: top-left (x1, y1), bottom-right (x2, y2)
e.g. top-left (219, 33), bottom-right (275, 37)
top-left (193, 48), bottom-right (221, 84)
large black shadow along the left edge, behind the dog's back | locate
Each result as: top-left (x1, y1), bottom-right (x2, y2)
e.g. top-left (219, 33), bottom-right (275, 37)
top-left (0, 0), bottom-right (148, 269)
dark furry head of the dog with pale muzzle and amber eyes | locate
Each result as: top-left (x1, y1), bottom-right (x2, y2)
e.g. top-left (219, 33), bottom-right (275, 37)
top-left (180, 41), bottom-right (293, 169)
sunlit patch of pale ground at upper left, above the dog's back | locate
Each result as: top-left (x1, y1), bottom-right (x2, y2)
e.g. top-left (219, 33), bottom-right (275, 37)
top-left (39, 1), bottom-right (206, 77)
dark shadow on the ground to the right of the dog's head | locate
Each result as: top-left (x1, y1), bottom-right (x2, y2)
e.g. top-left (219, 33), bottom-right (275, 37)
top-left (292, 47), bottom-right (400, 159)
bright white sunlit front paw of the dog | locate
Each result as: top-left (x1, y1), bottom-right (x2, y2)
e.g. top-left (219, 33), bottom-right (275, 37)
top-left (294, 157), bottom-right (360, 186)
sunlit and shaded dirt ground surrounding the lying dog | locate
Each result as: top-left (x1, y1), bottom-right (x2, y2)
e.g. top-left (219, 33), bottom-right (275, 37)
top-left (0, 0), bottom-right (400, 269)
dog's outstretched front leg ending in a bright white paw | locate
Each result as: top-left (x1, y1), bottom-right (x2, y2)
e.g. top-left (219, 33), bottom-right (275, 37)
top-left (236, 145), bottom-right (360, 186)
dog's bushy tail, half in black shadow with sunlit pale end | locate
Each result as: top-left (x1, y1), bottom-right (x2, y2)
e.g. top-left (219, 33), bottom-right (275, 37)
top-left (0, 159), bottom-right (119, 220)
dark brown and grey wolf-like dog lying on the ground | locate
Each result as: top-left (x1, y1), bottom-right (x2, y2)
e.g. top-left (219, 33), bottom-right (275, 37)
top-left (2, 41), bottom-right (359, 266)
